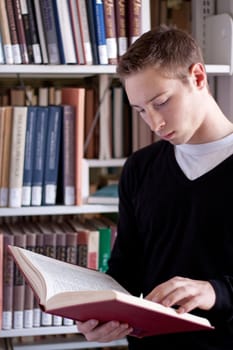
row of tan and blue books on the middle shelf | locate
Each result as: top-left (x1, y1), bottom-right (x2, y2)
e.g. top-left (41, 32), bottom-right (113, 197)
top-left (0, 88), bottom-right (85, 207)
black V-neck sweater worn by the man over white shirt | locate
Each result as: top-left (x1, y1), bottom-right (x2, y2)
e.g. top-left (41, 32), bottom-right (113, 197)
top-left (108, 141), bottom-right (233, 350)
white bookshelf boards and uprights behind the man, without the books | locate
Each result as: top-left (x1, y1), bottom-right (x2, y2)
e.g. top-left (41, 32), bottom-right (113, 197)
top-left (0, 0), bottom-right (231, 350)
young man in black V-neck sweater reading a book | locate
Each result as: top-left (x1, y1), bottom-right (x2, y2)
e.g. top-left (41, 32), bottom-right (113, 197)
top-left (78, 27), bottom-right (233, 350)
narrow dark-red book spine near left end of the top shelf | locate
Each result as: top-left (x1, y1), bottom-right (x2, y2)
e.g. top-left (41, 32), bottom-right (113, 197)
top-left (12, 0), bottom-right (29, 64)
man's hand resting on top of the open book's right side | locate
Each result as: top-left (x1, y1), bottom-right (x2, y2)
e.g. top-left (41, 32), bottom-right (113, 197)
top-left (145, 277), bottom-right (216, 313)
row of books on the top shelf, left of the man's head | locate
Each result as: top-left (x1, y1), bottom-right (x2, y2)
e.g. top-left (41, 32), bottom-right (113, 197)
top-left (0, 0), bottom-right (142, 64)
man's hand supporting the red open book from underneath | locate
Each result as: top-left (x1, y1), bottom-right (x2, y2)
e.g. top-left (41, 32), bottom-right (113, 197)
top-left (76, 320), bottom-right (133, 342)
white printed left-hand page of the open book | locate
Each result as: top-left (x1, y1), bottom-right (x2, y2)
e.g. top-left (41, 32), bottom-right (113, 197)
top-left (17, 248), bottom-right (129, 299)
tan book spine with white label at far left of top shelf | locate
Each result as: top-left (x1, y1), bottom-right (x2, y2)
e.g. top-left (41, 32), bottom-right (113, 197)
top-left (0, 1), bottom-right (14, 64)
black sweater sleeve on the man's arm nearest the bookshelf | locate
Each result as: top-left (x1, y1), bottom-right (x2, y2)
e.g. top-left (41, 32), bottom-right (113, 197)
top-left (107, 157), bottom-right (143, 295)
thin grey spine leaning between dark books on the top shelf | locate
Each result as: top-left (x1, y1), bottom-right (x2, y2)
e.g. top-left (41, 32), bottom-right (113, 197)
top-left (32, 0), bottom-right (49, 64)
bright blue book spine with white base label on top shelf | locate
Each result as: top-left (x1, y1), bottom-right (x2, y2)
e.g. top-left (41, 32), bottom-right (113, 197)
top-left (93, 0), bottom-right (108, 64)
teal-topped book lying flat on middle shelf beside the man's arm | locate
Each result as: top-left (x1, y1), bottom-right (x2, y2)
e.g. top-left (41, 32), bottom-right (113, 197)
top-left (87, 183), bottom-right (119, 204)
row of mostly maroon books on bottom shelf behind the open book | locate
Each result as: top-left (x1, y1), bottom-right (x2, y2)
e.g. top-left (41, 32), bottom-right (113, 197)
top-left (0, 216), bottom-right (116, 329)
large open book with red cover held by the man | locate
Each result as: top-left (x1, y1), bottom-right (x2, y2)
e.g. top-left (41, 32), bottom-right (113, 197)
top-left (8, 246), bottom-right (213, 337)
